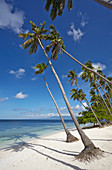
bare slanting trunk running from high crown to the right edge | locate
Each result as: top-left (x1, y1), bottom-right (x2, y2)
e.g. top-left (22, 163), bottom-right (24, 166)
top-left (61, 47), bottom-right (112, 85)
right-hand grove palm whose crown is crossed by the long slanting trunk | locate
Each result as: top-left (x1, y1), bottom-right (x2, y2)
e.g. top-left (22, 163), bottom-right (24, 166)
top-left (81, 61), bottom-right (112, 116)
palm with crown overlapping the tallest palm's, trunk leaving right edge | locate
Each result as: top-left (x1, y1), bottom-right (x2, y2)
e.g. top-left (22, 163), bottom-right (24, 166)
top-left (46, 25), bottom-right (112, 85)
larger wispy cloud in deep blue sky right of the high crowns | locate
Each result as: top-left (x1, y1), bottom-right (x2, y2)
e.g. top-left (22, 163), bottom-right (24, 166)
top-left (67, 23), bottom-right (84, 42)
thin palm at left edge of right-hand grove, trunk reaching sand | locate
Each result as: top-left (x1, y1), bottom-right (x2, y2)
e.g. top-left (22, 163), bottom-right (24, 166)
top-left (67, 70), bottom-right (102, 127)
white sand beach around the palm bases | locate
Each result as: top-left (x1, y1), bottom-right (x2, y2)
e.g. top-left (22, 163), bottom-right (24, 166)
top-left (0, 126), bottom-right (112, 170)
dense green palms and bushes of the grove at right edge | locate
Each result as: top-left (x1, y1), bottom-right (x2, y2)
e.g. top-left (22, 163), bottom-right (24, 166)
top-left (75, 61), bottom-right (112, 125)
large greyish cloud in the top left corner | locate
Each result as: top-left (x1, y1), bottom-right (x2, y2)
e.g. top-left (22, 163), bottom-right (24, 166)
top-left (0, 0), bottom-right (24, 34)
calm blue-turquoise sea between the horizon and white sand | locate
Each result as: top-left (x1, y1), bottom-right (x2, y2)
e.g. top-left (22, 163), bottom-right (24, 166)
top-left (0, 119), bottom-right (75, 149)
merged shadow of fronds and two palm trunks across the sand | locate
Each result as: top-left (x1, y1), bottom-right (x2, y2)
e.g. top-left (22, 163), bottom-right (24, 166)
top-left (2, 142), bottom-right (87, 170)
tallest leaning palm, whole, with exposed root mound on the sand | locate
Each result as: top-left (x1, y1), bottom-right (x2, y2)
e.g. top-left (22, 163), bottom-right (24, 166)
top-left (19, 21), bottom-right (102, 161)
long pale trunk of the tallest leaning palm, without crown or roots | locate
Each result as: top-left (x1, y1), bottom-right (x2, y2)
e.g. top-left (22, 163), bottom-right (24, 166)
top-left (38, 38), bottom-right (95, 149)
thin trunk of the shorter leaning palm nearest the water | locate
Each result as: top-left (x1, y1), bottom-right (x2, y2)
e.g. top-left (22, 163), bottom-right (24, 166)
top-left (43, 72), bottom-right (78, 142)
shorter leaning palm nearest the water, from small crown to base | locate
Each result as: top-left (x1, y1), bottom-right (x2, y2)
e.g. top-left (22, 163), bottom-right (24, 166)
top-left (34, 63), bottom-right (78, 142)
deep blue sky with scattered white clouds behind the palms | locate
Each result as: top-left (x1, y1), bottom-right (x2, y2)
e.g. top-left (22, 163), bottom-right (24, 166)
top-left (0, 0), bottom-right (112, 119)
